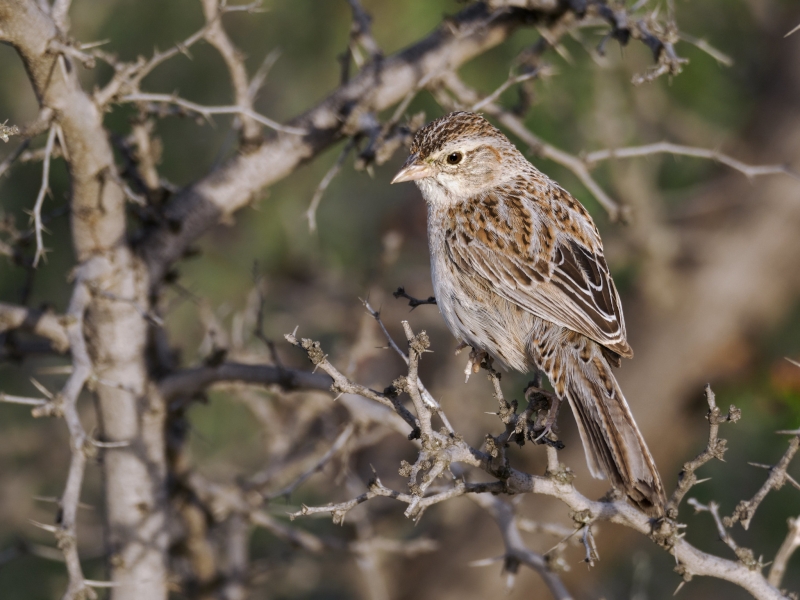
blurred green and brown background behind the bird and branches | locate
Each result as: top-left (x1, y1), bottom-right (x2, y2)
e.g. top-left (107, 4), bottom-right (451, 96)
top-left (0, 0), bottom-right (800, 600)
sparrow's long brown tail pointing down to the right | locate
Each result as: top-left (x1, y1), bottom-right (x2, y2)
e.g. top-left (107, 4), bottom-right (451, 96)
top-left (548, 339), bottom-right (666, 517)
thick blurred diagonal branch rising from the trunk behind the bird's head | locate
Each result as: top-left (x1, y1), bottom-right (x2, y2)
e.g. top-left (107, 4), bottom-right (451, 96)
top-left (140, 2), bottom-right (561, 285)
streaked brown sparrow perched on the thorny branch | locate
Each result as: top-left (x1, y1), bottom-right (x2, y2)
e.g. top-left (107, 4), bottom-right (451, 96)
top-left (392, 111), bottom-right (666, 518)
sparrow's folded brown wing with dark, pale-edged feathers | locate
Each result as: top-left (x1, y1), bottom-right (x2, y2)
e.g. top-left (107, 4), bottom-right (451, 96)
top-left (445, 188), bottom-right (633, 357)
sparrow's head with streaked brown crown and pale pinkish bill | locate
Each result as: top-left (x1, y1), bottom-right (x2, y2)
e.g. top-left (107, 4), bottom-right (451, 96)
top-left (392, 112), bottom-right (519, 203)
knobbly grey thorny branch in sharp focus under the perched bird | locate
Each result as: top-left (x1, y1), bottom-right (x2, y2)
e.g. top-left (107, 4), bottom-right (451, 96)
top-left (287, 322), bottom-right (784, 600)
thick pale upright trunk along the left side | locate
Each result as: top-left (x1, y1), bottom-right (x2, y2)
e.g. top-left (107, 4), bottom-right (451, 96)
top-left (0, 0), bottom-right (167, 600)
